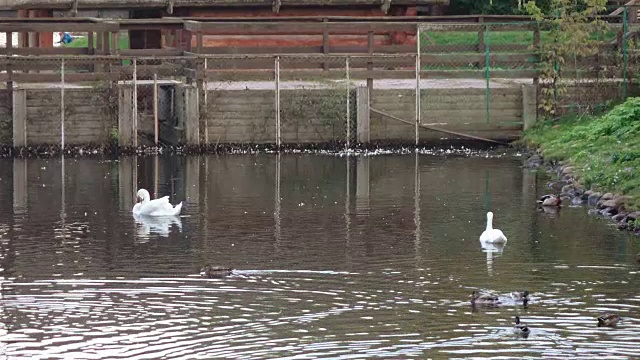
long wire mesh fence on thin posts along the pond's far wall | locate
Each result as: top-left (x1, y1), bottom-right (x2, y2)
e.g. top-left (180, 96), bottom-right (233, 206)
top-left (0, 6), bottom-right (640, 149)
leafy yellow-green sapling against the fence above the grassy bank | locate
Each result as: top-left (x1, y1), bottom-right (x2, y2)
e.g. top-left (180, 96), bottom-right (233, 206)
top-left (525, 0), bottom-right (608, 114)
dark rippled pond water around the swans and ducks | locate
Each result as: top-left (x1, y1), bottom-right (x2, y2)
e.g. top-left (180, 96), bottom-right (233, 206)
top-left (0, 152), bottom-right (640, 359)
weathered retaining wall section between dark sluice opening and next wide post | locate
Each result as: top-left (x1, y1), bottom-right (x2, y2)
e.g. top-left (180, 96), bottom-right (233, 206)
top-left (205, 89), bottom-right (355, 144)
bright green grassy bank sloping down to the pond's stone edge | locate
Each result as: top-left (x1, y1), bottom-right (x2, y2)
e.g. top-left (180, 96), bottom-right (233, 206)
top-left (523, 97), bottom-right (640, 209)
